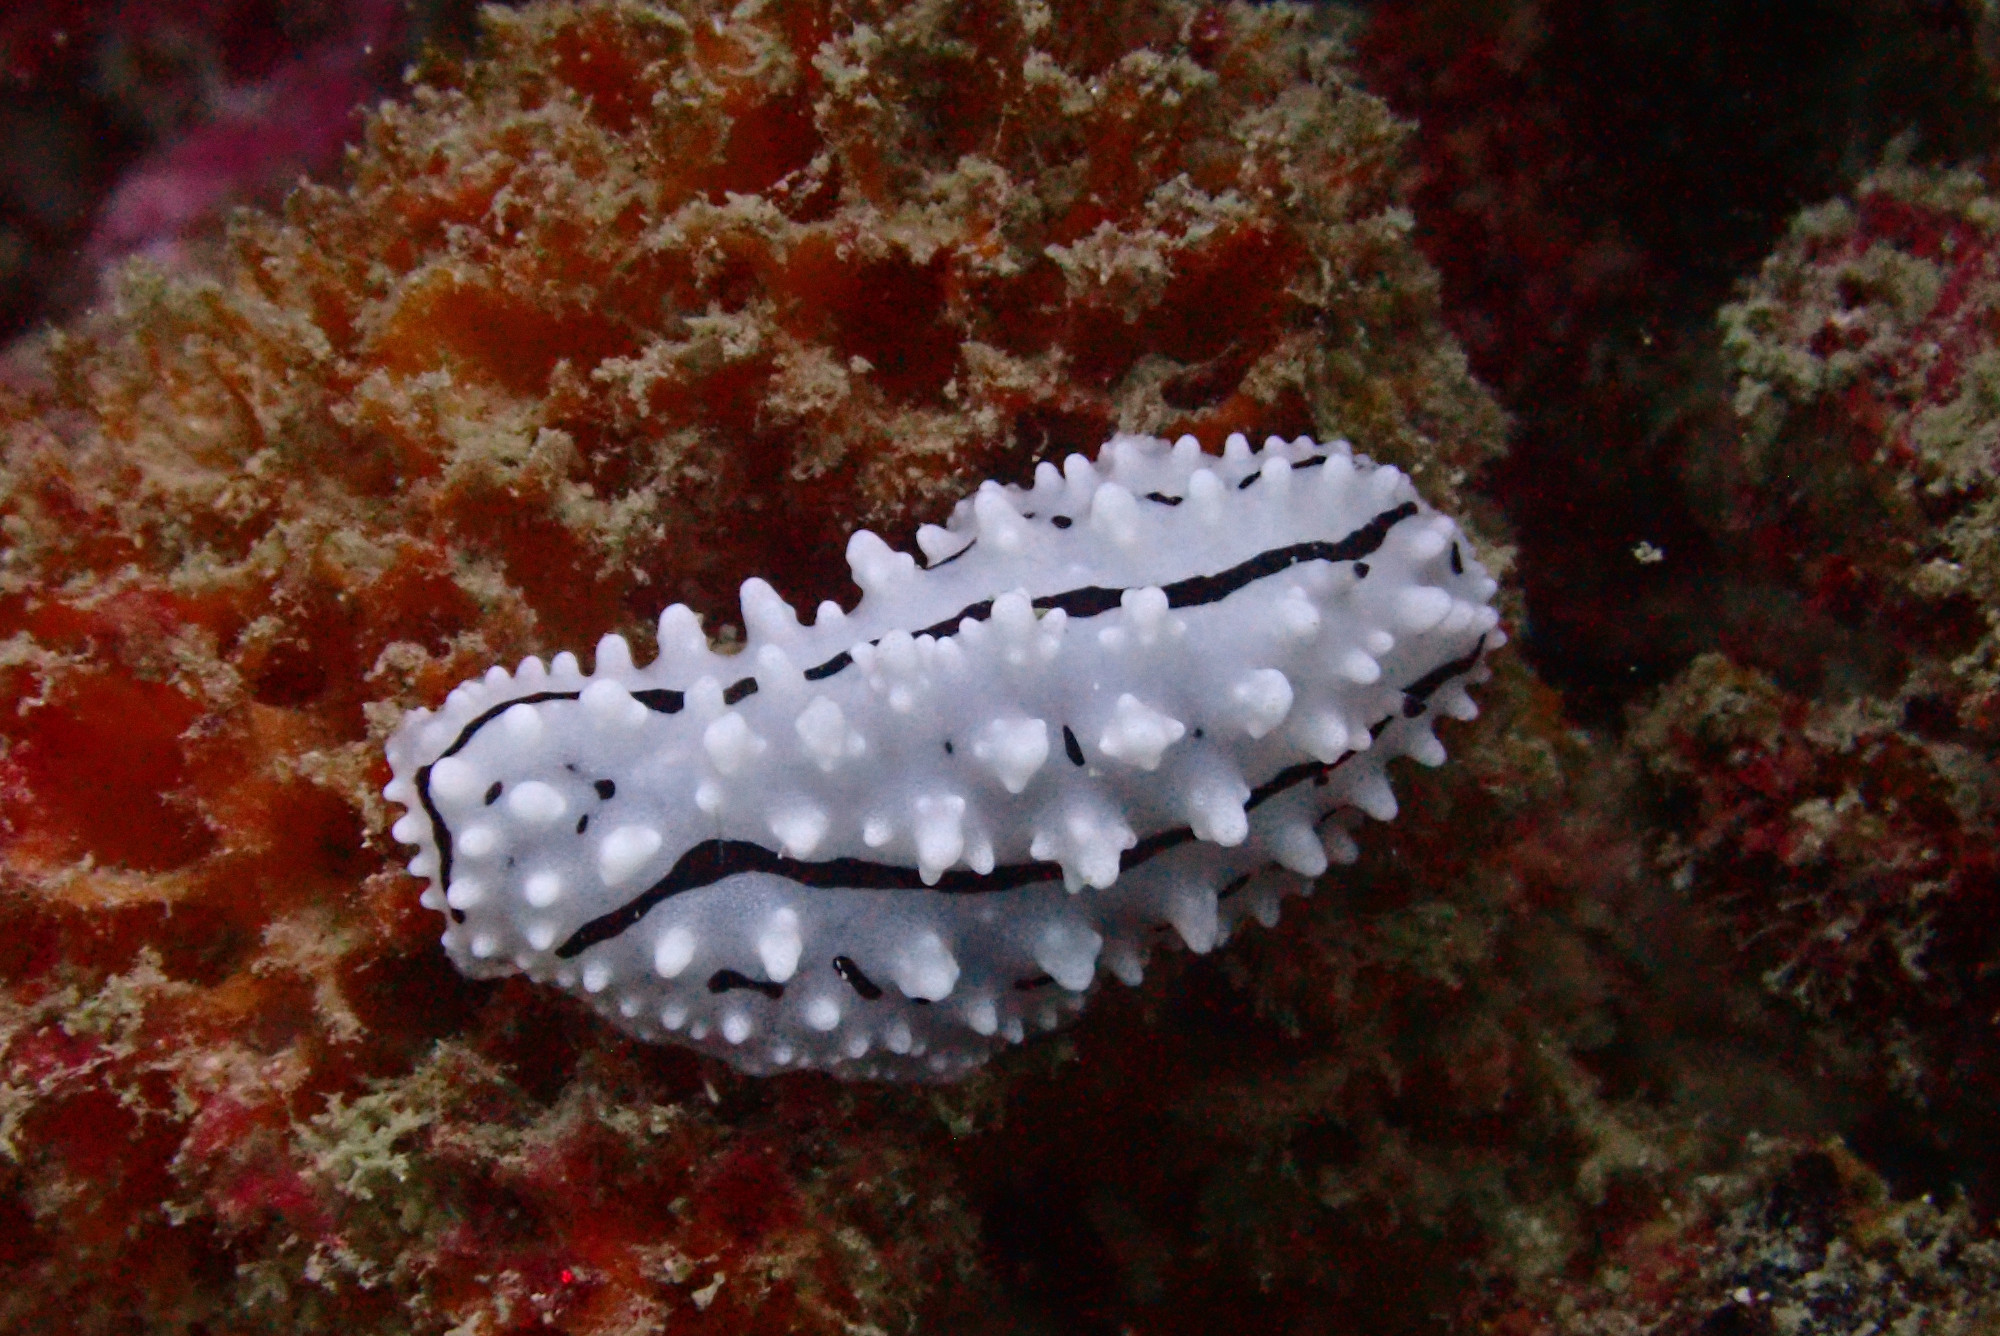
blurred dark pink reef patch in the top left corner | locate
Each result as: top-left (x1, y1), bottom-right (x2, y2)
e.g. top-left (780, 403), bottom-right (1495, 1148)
top-left (0, 0), bottom-right (436, 340)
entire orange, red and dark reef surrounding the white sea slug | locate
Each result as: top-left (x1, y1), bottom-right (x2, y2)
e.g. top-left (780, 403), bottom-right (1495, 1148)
top-left (11, 0), bottom-right (2000, 1336)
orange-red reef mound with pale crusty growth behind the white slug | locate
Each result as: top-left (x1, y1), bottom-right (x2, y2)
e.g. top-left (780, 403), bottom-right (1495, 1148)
top-left (0, 0), bottom-right (1498, 1332)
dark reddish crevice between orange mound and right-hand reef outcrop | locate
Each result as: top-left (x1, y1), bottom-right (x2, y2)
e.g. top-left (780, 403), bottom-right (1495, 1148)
top-left (1358, 0), bottom-right (2000, 724)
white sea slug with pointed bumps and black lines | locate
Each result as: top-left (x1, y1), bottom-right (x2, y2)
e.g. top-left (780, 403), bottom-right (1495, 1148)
top-left (384, 436), bottom-right (1504, 1080)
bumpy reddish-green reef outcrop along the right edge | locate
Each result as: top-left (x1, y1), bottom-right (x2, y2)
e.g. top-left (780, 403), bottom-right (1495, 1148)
top-left (1632, 157), bottom-right (2000, 1208)
